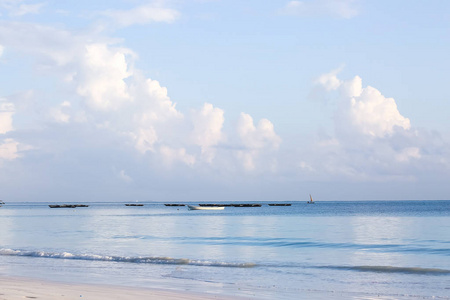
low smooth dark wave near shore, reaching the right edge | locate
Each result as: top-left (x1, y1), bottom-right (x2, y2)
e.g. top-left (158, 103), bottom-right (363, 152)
top-left (316, 266), bottom-right (450, 275)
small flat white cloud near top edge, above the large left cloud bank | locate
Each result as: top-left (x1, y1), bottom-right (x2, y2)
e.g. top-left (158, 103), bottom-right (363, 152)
top-left (103, 3), bottom-right (180, 26)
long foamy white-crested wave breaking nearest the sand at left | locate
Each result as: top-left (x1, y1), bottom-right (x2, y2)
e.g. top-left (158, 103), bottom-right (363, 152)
top-left (0, 249), bottom-right (256, 268)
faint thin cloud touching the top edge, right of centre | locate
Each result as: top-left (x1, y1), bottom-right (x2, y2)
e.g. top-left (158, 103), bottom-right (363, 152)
top-left (281, 0), bottom-right (359, 19)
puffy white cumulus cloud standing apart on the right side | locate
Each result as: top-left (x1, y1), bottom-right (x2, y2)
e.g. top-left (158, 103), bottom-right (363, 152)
top-left (300, 69), bottom-right (434, 180)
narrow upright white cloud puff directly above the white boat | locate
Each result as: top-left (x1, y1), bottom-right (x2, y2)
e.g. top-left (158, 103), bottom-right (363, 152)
top-left (192, 103), bottom-right (225, 163)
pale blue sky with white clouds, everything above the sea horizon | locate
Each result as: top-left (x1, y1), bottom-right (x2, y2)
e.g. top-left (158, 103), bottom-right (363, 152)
top-left (0, 0), bottom-right (450, 202)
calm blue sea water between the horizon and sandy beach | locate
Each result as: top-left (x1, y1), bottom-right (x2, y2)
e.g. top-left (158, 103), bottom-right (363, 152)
top-left (0, 201), bottom-right (450, 299)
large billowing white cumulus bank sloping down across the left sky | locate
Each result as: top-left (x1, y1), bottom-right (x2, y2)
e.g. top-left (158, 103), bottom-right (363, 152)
top-left (0, 15), bottom-right (281, 177)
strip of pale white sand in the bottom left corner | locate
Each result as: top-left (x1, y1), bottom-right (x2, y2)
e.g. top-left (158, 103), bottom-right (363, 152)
top-left (0, 277), bottom-right (244, 300)
